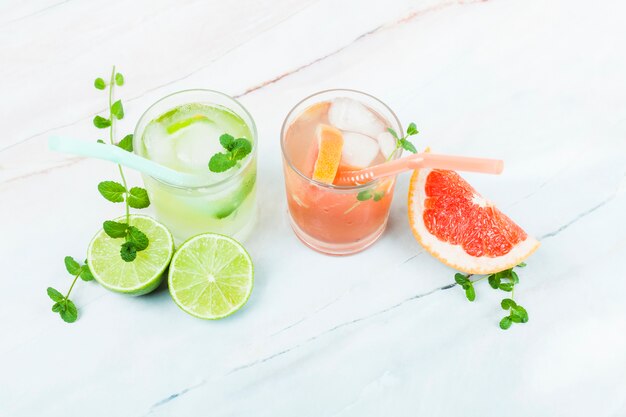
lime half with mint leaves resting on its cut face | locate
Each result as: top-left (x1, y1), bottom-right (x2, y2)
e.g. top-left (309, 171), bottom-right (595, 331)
top-left (87, 215), bottom-right (174, 295)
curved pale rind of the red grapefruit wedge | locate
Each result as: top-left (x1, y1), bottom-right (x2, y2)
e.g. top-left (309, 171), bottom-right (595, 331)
top-left (408, 169), bottom-right (540, 275)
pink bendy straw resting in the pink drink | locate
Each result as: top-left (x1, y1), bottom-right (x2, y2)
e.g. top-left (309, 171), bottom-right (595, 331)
top-left (335, 153), bottom-right (504, 185)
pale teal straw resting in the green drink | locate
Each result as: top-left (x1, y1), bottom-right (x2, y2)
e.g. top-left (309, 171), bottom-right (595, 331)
top-left (48, 136), bottom-right (207, 187)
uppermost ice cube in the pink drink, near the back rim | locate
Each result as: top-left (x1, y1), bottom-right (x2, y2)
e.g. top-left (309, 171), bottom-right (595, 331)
top-left (328, 97), bottom-right (385, 138)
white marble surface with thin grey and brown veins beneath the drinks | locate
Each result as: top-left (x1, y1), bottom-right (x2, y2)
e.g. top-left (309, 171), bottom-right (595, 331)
top-left (0, 0), bottom-right (626, 417)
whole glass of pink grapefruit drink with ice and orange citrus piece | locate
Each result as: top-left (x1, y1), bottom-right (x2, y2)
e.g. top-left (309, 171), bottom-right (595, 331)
top-left (281, 90), bottom-right (402, 255)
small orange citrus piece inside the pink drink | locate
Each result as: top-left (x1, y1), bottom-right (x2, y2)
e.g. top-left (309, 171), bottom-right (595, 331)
top-left (313, 124), bottom-right (343, 184)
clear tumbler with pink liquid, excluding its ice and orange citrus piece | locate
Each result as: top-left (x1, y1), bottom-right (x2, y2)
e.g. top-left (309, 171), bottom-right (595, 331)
top-left (281, 89), bottom-right (402, 255)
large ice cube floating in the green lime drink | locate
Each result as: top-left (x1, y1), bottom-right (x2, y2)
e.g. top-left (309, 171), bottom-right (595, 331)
top-left (172, 123), bottom-right (224, 173)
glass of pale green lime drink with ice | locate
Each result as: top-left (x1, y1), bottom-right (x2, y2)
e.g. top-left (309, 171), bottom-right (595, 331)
top-left (133, 90), bottom-right (257, 244)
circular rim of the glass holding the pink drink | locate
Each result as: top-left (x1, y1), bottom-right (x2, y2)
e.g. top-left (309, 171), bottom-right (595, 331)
top-left (280, 88), bottom-right (403, 191)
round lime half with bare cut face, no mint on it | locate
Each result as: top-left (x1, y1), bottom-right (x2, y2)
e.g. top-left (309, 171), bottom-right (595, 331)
top-left (168, 233), bottom-right (254, 320)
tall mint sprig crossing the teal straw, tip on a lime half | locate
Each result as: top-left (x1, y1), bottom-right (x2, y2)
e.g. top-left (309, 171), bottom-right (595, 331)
top-left (93, 66), bottom-right (150, 262)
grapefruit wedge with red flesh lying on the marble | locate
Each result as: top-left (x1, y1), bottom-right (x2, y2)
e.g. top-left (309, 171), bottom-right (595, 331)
top-left (409, 169), bottom-right (539, 274)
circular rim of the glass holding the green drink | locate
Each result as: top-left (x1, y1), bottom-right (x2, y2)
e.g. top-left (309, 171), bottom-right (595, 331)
top-left (133, 88), bottom-right (258, 190)
